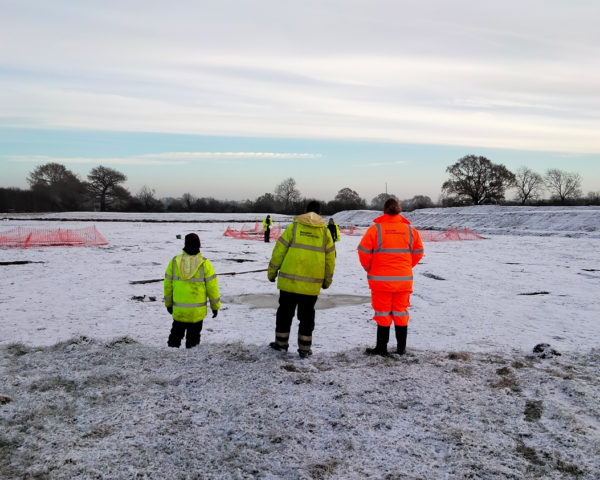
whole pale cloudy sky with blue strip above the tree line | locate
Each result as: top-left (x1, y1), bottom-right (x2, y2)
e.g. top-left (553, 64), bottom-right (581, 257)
top-left (0, 0), bottom-right (600, 201)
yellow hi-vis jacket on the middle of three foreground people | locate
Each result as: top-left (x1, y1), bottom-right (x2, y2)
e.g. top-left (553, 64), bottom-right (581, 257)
top-left (267, 212), bottom-right (335, 295)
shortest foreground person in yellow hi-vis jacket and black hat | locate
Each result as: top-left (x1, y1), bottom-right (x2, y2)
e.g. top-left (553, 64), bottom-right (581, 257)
top-left (164, 233), bottom-right (221, 348)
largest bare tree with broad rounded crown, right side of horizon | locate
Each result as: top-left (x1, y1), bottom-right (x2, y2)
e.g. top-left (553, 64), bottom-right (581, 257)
top-left (442, 155), bottom-right (515, 205)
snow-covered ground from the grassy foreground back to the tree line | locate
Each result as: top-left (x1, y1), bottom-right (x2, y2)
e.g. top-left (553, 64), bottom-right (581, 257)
top-left (0, 207), bottom-right (600, 479)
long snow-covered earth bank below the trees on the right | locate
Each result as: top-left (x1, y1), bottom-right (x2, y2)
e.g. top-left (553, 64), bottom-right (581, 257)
top-left (333, 205), bottom-right (600, 238)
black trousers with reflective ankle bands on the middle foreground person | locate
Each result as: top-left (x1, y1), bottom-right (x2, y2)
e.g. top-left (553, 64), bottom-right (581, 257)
top-left (275, 290), bottom-right (319, 350)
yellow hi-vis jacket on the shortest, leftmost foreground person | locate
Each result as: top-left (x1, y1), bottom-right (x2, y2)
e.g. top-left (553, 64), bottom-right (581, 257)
top-left (164, 252), bottom-right (221, 323)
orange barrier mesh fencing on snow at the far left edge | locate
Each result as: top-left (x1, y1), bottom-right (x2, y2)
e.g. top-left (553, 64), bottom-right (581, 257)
top-left (0, 226), bottom-right (108, 248)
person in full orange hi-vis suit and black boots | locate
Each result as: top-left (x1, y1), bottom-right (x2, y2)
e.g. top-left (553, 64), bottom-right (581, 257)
top-left (358, 198), bottom-right (424, 356)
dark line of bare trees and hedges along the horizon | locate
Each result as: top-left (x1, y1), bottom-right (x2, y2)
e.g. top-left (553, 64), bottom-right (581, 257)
top-left (0, 155), bottom-right (600, 215)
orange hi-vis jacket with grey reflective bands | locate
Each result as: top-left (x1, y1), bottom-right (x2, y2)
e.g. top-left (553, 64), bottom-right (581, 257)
top-left (358, 214), bottom-right (424, 292)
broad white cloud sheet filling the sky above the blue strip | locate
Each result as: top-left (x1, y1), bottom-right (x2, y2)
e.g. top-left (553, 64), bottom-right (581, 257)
top-left (0, 0), bottom-right (600, 154)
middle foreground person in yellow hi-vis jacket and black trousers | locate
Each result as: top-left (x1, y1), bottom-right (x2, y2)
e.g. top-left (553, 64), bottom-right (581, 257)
top-left (267, 201), bottom-right (335, 358)
